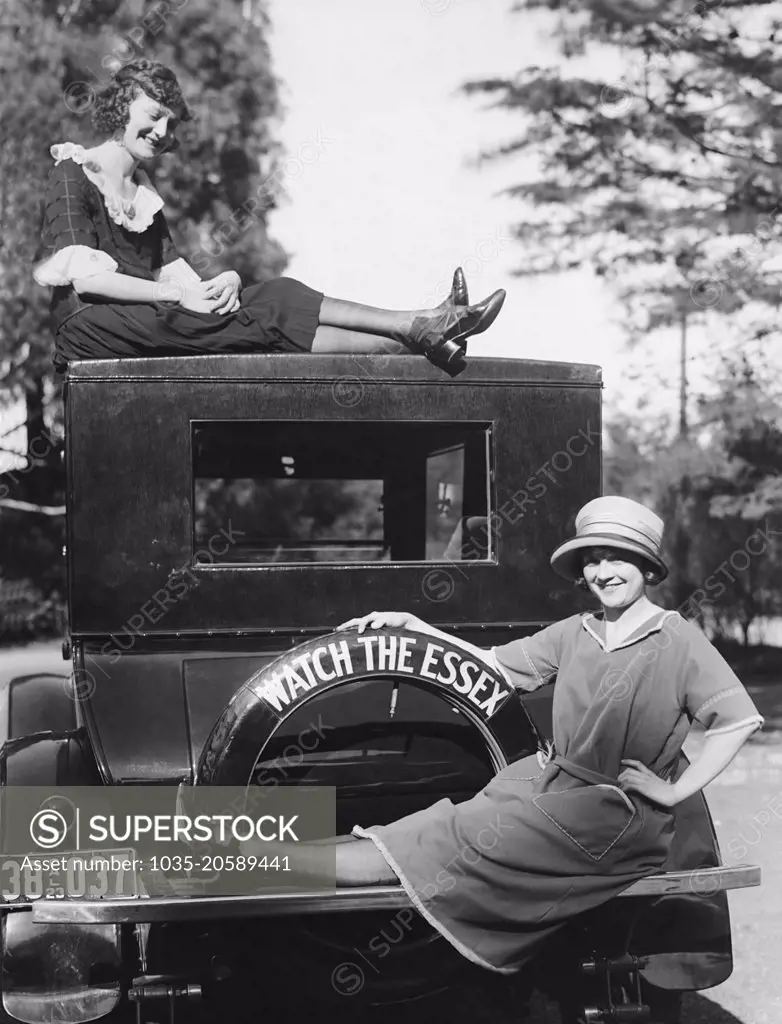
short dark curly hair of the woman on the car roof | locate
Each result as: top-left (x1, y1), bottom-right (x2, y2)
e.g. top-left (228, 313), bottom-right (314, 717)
top-left (92, 57), bottom-right (192, 135)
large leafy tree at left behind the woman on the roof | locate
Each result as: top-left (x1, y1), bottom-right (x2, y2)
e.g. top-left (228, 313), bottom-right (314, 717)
top-left (0, 0), bottom-right (286, 634)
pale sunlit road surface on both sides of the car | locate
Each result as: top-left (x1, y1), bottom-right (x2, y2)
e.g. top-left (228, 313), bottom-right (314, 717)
top-left (0, 641), bottom-right (782, 1024)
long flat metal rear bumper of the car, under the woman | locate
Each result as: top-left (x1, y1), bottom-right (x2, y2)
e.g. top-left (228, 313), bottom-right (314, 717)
top-left (25, 865), bottom-right (761, 925)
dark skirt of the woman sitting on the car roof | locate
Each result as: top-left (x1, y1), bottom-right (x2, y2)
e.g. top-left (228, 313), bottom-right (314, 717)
top-left (54, 278), bottom-right (323, 372)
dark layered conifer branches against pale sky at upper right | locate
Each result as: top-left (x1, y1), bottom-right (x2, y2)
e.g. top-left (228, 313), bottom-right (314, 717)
top-left (465, 0), bottom-right (782, 331)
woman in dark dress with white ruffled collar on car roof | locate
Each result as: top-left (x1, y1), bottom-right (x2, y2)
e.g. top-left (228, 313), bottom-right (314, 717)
top-left (34, 59), bottom-right (505, 377)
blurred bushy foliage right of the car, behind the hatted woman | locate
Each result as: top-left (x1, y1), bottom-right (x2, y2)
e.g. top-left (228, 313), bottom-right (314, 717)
top-left (605, 356), bottom-right (782, 643)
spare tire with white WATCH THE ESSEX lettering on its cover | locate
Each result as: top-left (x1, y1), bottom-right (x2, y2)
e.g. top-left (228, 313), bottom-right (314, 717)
top-left (197, 630), bottom-right (538, 1004)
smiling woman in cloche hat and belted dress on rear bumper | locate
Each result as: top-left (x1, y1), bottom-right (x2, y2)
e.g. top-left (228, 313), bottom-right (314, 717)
top-left (246, 497), bottom-right (764, 973)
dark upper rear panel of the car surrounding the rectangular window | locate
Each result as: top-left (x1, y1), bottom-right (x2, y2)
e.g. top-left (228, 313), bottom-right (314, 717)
top-left (68, 357), bottom-right (601, 634)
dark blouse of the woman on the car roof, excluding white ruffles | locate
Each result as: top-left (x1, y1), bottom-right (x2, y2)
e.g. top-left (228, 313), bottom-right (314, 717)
top-left (37, 160), bottom-right (179, 331)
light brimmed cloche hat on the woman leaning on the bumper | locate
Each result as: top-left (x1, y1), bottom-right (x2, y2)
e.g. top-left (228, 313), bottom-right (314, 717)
top-left (551, 495), bottom-right (668, 580)
